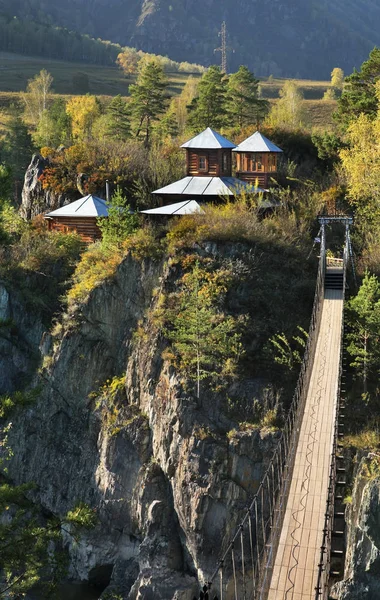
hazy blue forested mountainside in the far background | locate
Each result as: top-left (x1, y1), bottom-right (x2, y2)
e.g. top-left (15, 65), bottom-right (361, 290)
top-left (0, 0), bottom-right (380, 79)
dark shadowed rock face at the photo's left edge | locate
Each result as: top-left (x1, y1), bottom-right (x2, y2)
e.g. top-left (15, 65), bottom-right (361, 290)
top-left (0, 281), bottom-right (44, 395)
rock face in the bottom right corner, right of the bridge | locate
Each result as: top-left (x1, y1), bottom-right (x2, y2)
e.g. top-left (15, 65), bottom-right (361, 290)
top-left (332, 455), bottom-right (380, 600)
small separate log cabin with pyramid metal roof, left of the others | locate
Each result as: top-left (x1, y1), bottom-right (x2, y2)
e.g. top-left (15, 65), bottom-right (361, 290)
top-left (45, 194), bottom-right (108, 243)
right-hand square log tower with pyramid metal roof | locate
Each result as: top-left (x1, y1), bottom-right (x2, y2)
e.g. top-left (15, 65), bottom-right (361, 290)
top-left (233, 131), bottom-right (282, 189)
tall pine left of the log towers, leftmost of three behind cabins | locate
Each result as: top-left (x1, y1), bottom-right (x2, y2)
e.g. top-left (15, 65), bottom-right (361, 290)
top-left (129, 60), bottom-right (167, 146)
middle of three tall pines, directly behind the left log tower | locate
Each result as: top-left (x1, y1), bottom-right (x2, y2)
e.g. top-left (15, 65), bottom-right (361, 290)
top-left (188, 65), bottom-right (228, 131)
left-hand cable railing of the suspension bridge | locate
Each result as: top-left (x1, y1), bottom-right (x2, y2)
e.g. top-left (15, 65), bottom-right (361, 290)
top-left (207, 246), bottom-right (326, 600)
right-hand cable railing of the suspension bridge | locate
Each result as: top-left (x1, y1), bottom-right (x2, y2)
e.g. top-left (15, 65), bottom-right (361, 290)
top-left (315, 236), bottom-right (349, 600)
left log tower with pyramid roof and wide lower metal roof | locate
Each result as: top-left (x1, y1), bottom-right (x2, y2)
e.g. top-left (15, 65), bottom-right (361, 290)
top-left (153, 127), bottom-right (262, 205)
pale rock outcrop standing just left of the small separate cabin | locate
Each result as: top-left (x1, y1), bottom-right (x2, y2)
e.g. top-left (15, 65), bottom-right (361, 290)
top-left (20, 154), bottom-right (69, 219)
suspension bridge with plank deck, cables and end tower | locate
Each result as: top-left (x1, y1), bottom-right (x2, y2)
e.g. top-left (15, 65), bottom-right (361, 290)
top-left (200, 217), bottom-right (352, 600)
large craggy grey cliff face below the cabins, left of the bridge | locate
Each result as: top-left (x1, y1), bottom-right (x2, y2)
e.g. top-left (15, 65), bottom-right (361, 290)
top-left (3, 257), bottom-right (276, 600)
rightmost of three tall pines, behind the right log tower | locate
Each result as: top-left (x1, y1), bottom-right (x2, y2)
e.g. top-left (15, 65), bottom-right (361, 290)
top-left (226, 66), bottom-right (269, 127)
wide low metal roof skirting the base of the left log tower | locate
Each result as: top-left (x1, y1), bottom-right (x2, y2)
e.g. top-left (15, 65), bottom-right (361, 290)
top-left (153, 176), bottom-right (265, 197)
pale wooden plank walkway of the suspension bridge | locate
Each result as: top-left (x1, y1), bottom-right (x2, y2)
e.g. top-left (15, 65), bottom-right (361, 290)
top-left (268, 289), bottom-right (343, 600)
